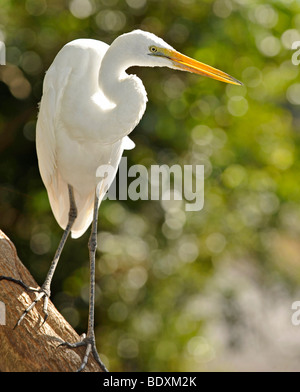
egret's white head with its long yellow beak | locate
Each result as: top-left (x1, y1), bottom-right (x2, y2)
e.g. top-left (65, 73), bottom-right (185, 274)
top-left (116, 30), bottom-right (242, 85)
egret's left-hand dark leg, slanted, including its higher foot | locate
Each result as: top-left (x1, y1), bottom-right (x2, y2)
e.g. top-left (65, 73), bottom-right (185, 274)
top-left (0, 185), bottom-right (77, 328)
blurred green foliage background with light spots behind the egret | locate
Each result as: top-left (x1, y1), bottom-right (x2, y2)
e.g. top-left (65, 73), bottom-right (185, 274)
top-left (0, 0), bottom-right (300, 371)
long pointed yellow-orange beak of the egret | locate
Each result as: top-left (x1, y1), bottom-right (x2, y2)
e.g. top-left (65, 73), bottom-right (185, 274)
top-left (163, 49), bottom-right (243, 86)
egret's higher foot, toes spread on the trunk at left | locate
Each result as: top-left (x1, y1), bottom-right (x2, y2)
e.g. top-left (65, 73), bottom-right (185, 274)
top-left (0, 275), bottom-right (50, 329)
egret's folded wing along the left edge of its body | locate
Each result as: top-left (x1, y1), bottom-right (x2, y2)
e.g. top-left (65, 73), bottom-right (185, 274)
top-left (36, 68), bottom-right (71, 228)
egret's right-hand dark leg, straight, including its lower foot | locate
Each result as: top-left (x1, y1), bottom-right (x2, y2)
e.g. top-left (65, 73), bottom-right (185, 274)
top-left (60, 188), bottom-right (108, 372)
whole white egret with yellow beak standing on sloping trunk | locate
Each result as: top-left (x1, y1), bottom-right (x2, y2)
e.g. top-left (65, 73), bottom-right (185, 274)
top-left (0, 30), bottom-right (241, 370)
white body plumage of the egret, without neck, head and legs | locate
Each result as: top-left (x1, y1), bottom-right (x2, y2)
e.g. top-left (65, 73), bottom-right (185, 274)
top-left (36, 39), bottom-right (142, 238)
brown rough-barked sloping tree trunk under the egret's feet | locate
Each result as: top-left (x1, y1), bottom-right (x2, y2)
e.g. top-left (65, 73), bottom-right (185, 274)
top-left (0, 230), bottom-right (101, 372)
